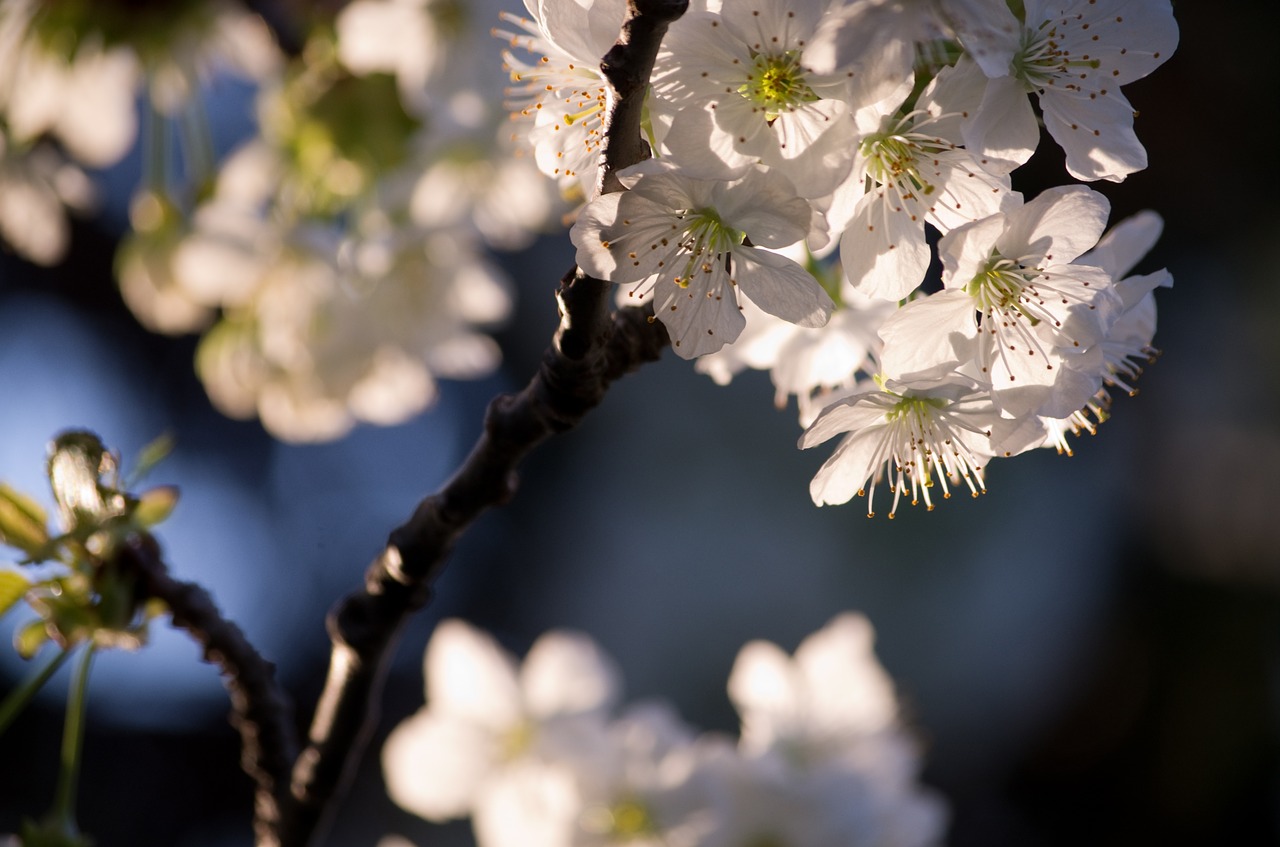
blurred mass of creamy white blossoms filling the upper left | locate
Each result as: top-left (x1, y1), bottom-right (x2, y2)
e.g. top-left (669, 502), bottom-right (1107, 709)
top-left (0, 0), bottom-right (562, 441)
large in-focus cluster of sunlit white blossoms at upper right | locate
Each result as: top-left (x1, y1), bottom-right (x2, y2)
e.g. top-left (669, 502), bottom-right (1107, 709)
top-left (545, 0), bottom-right (1178, 517)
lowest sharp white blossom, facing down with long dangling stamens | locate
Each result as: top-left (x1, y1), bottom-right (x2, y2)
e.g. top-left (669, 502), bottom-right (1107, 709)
top-left (800, 376), bottom-right (1000, 518)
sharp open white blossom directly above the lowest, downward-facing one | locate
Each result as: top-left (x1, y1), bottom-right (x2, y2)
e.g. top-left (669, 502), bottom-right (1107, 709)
top-left (881, 186), bottom-right (1120, 417)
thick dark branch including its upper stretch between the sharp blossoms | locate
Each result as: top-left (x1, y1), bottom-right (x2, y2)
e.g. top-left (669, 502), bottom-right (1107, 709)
top-left (275, 0), bottom-right (687, 847)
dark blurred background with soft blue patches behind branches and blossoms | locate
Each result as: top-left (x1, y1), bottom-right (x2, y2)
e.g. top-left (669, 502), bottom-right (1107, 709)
top-left (0, 3), bottom-right (1280, 847)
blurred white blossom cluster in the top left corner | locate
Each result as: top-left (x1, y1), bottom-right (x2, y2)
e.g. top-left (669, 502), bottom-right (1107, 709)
top-left (0, 0), bottom-right (279, 265)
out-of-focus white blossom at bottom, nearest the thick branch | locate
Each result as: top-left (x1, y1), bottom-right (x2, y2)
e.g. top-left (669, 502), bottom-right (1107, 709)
top-left (383, 621), bottom-right (618, 823)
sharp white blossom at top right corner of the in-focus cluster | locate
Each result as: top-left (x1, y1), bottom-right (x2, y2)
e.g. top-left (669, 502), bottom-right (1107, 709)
top-left (965, 0), bottom-right (1178, 182)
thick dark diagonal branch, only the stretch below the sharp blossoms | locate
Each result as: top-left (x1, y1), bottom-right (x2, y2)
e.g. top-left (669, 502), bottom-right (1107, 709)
top-left (279, 300), bottom-right (668, 847)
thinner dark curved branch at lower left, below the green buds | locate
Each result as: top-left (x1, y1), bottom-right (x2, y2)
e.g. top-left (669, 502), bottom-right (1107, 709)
top-left (118, 535), bottom-right (297, 846)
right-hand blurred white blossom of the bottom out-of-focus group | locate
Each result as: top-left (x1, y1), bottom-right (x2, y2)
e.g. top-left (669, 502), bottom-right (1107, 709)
top-left (707, 613), bottom-right (946, 847)
